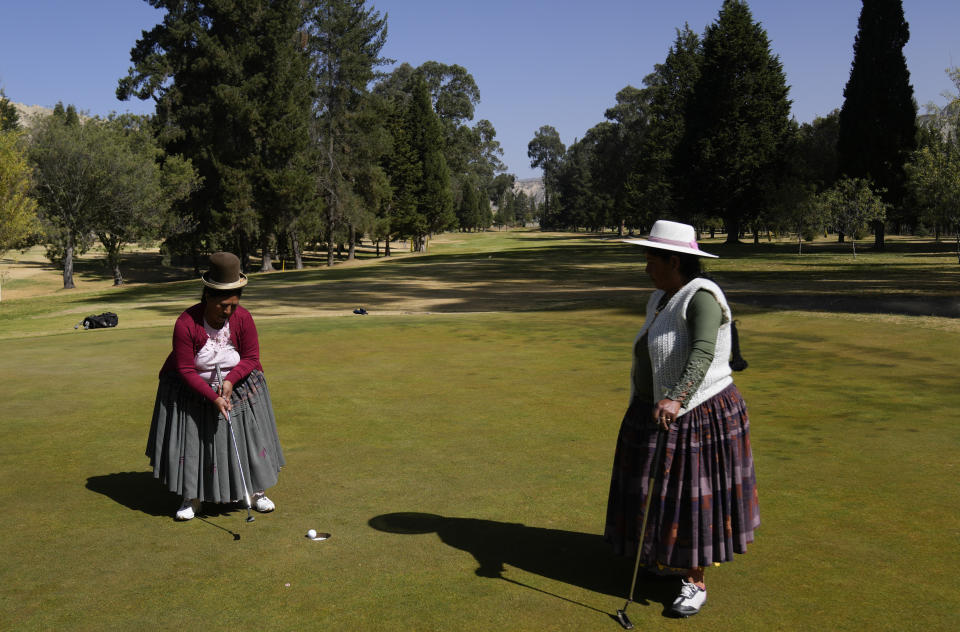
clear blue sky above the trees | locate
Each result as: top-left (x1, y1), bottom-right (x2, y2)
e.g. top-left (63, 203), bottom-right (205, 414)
top-left (0, 0), bottom-right (960, 178)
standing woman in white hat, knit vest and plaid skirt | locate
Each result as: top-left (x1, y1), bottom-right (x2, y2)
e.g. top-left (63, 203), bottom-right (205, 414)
top-left (604, 220), bottom-right (760, 617)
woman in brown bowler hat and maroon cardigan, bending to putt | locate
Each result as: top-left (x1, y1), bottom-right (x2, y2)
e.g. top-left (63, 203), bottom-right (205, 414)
top-left (147, 252), bottom-right (285, 520)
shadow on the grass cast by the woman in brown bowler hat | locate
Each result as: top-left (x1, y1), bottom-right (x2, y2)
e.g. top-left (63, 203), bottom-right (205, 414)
top-left (87, 472), bottom-right (243, 540)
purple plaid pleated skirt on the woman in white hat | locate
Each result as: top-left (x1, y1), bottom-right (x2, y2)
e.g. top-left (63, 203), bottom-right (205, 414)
top-left (604, 384), bottom-right (760, 569)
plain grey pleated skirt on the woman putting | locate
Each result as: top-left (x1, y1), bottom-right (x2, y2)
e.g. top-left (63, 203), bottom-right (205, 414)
top-left (146, 371), bottom-right (286, 503)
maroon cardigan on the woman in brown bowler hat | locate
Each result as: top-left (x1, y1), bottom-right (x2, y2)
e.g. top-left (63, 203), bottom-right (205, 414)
top-left (160, 303), bottom-right (263, 402)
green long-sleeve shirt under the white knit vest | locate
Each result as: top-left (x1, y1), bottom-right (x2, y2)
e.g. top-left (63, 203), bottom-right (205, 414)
top-left (633, 290), bottom-right (723, 405)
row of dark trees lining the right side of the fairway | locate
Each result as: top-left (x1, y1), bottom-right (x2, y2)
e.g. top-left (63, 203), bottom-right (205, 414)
top-left (528, 0), bottom-right (960, 252)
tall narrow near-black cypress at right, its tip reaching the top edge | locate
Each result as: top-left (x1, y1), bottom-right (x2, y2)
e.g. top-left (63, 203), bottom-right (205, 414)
top-left (837, 0), bottom-right (917, 244)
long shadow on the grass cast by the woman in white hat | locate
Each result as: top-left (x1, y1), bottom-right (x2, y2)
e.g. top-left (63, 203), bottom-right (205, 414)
top-left (368, 512), bottom-right (678, 612)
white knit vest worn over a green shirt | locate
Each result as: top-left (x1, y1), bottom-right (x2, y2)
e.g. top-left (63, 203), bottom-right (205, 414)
top-left (630, 277), bottom-right (733, 415)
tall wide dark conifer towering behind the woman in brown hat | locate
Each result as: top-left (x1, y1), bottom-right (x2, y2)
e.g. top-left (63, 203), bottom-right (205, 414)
top-left (117, 0), bottom-right (312, 269)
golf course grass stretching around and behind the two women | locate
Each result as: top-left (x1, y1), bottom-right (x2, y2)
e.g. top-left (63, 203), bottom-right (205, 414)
top-left (0, 232), bottom-right (960, 631)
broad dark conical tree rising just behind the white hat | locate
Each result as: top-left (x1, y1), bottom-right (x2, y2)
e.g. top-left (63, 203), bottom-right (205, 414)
top-left (681, 0), bottom-right (790, 242)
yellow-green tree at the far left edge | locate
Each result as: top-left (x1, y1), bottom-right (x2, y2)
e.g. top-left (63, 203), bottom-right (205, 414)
top-left (0, 130), bottom-right (38, 255)
